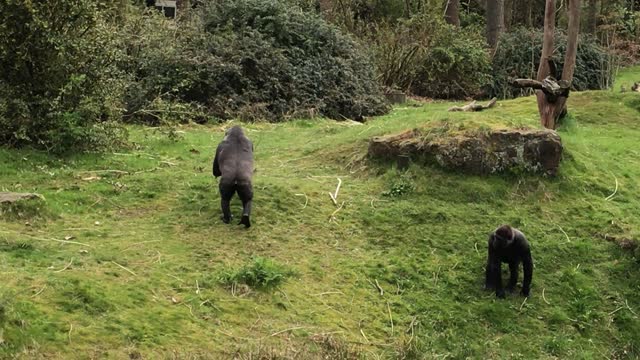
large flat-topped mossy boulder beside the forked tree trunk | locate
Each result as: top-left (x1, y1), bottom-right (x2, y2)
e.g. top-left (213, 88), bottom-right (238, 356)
top-left (369, 128), bottom-right (562, 176)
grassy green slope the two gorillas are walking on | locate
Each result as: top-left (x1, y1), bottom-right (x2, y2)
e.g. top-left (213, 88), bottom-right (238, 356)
top-left (0, 68), bottom-right (640, 359)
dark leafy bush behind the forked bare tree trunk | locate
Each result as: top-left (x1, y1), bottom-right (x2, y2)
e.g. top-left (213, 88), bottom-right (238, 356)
top-left (488, 29), bottom-right (614, 98)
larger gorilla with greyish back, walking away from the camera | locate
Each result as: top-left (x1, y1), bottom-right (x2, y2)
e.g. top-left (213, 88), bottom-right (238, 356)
top-left (213, 126), bottom-right (253, 227)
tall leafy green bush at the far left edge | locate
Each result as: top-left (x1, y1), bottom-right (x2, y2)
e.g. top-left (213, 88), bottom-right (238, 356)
top-left (0, 0), bottom-right (125, 152)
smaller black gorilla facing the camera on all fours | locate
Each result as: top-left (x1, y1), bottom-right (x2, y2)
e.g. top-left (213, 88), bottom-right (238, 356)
top-left (485, 225), bottom-right (533, 299)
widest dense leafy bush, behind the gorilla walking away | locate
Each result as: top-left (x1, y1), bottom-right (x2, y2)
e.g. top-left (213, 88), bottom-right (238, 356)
top-left (122, 0), bottom-right (388, 121)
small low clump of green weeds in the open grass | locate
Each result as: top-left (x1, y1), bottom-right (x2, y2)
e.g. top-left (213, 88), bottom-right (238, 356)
top-left (220, 257), bottom-right (293, 290)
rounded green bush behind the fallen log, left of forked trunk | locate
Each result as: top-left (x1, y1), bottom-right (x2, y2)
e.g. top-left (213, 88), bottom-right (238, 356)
top-left (368, 14), bottom-right (491, 99)
